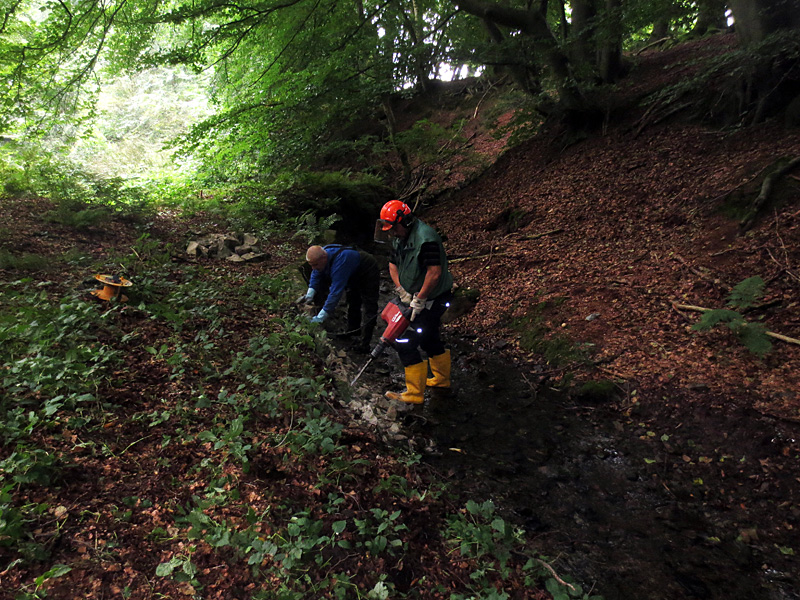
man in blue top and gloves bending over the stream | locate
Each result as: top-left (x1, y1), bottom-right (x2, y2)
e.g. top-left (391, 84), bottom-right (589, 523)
top-left (305, 244), bottom-right (380, 352)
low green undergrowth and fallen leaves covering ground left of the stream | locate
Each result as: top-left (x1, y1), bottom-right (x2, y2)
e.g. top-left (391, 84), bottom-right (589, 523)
top-left (0, 195), bottom-right (587, 600)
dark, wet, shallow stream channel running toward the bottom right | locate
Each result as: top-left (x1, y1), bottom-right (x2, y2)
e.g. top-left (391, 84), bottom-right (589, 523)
top-left (344, 334), bottom-right (800, 600)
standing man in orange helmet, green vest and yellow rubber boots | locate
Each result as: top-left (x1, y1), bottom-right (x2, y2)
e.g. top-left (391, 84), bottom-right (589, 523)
top-left (376, 200), bottom-right (453, 404)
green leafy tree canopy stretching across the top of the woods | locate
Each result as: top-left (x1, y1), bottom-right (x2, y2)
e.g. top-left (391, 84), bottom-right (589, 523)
top-left (0, 0), bottom-right (800, 180)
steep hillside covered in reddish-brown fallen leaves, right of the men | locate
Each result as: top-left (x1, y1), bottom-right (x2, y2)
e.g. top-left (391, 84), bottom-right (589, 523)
top-left (425, 36), bottom-right (800, 420)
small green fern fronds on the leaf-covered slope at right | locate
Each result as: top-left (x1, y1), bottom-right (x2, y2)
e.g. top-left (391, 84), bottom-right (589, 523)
top-left (692, 276), bottom-right (772, 358)
